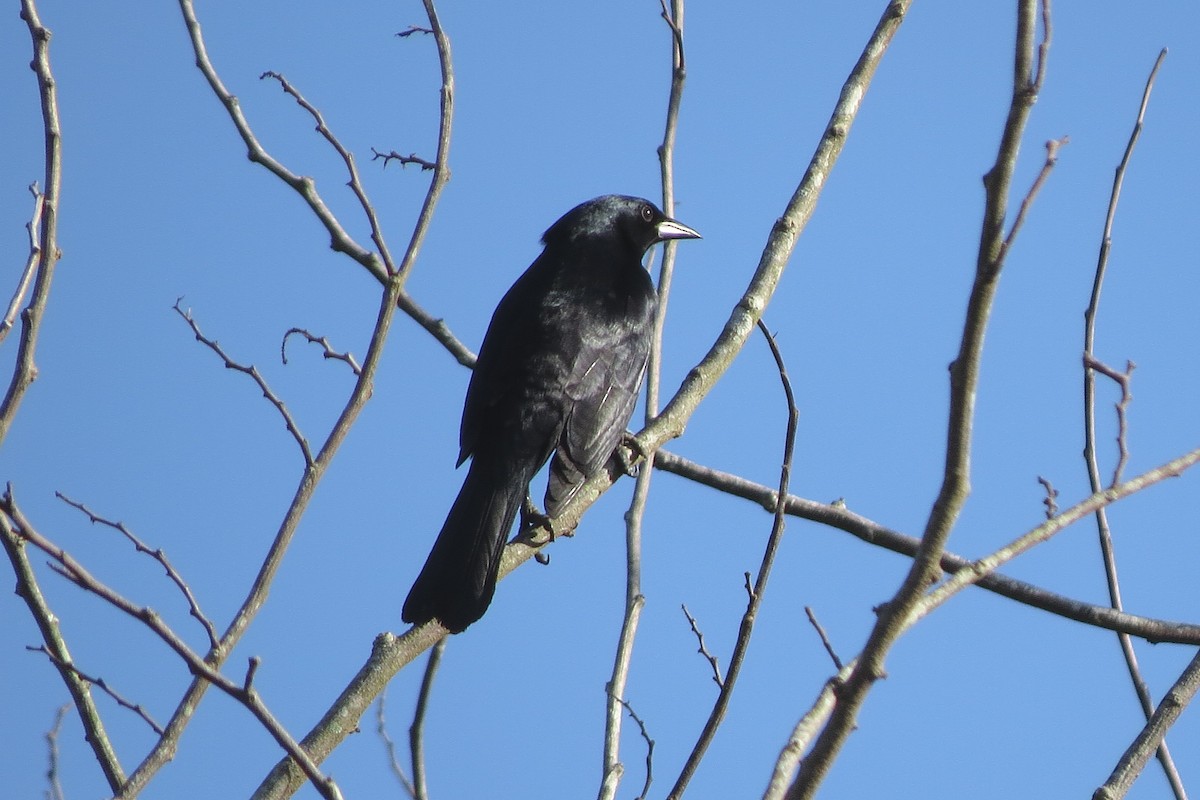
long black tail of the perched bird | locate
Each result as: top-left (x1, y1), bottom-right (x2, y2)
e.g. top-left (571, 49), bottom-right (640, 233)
top-left (402, 459), bottom-right (530, 633)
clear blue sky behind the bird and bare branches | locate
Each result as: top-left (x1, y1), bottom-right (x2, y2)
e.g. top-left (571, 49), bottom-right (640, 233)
top-left (0, 0), bottom-right (1200, 798)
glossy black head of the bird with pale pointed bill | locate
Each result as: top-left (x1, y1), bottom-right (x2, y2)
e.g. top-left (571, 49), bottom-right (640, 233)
top-left (541, 194), bottom-right (700, 257)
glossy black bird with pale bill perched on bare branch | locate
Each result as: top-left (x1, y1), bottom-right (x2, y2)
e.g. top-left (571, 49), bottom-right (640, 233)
top-left (403, 194), bottom-right (700, 633)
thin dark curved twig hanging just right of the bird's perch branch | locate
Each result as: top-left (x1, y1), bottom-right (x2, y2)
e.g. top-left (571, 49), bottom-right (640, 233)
top-left (667, 319), bottom-right (800, 800)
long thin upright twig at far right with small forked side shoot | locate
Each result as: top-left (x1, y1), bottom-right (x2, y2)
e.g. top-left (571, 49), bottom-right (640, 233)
top-left (1084, 48), bottom-right (1187, 800)
